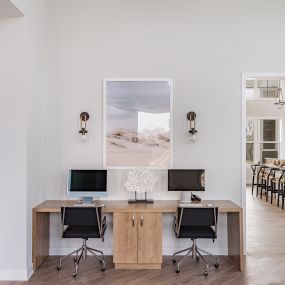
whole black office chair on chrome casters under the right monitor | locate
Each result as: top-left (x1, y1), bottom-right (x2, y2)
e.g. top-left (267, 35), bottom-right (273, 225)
top-left (172, 207), bottom-right (219, 276)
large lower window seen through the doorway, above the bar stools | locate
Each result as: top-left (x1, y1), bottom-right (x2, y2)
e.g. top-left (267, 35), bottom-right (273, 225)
top-left (246, 119), bottom-right (281, 163)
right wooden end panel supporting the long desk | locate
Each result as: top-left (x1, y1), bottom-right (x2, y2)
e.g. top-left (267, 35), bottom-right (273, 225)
top-left (227, 211), bottom-right (244, 271)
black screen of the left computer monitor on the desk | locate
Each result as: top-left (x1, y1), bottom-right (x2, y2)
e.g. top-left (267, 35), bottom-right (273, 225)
top-left (69, 170), bottom-right (107, 193)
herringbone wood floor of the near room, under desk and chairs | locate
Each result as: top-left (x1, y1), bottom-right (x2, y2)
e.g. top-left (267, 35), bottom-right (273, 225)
top-left (0, 255), bottom-right (285, 285)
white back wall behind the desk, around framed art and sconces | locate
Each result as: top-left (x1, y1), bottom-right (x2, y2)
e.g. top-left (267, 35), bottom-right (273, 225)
top-left (44, 0), bottom-right (285, 254)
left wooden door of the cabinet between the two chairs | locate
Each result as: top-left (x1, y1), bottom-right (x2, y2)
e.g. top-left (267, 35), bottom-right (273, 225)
top-left (113, 213), bottom-right (138, 263)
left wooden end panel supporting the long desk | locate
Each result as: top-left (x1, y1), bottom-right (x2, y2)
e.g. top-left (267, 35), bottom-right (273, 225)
top-left (32, 211), bottom-right (49, 270)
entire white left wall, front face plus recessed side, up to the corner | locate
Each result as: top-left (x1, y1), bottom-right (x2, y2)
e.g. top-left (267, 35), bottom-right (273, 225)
top-left (0, 0), bottom-right (45, 280)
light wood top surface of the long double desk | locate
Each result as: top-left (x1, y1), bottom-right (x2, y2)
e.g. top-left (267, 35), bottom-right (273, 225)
top-left (33, 200), bottom-right (242, 213)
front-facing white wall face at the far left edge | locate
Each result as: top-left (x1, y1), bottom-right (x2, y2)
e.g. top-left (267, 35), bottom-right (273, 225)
top-left (0, 15), bottom-right (27, 279)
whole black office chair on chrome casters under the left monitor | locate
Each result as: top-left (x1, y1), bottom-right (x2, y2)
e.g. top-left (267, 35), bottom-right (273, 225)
top-left (57, 206), bottom-right (106, 277)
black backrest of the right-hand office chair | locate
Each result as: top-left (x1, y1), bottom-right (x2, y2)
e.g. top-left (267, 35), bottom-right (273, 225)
top-left (177, 207), bottom-right (218, 226)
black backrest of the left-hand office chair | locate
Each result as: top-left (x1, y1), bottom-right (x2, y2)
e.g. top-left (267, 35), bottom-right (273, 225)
top-left (61, 206), bottom-right (102, 227)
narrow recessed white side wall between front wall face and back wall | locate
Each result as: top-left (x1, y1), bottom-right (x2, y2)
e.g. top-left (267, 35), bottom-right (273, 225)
top-left (24, 0), bottom-right (47, 275)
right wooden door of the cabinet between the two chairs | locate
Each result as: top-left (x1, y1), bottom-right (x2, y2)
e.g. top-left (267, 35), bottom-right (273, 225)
top-left (138, 213), bottom-right (162, 263)
